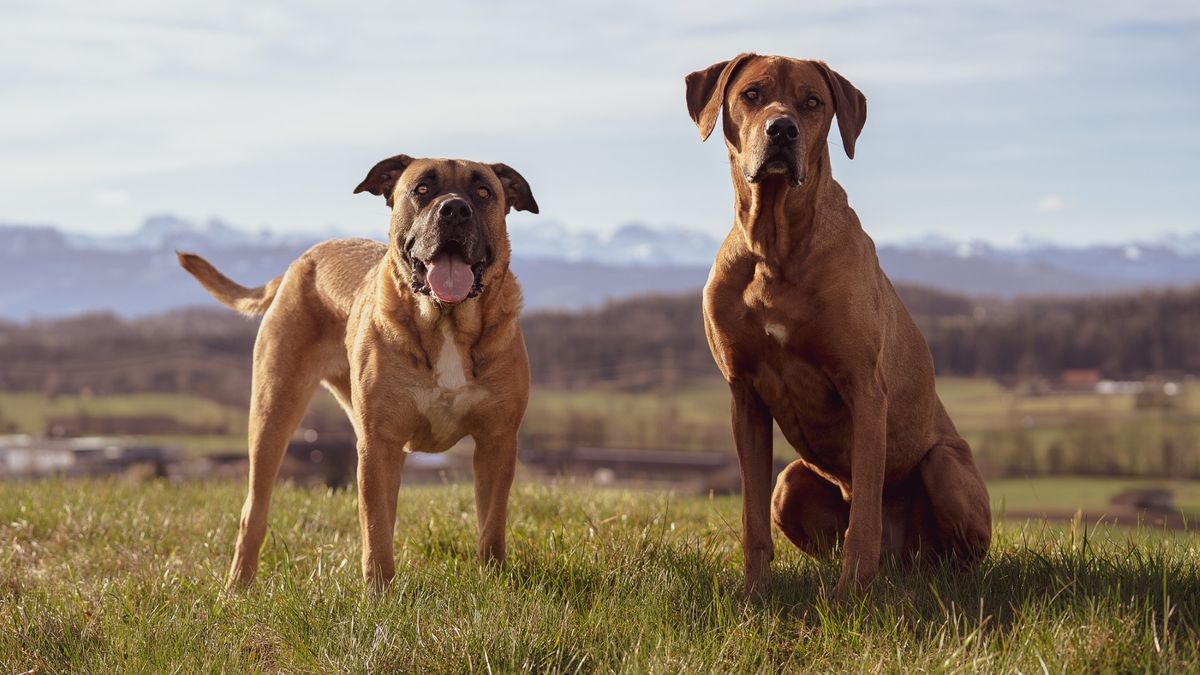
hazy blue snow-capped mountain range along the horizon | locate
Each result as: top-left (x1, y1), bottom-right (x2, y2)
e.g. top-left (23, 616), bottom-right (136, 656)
top-left (0, 215), bottom-right (1200, 321)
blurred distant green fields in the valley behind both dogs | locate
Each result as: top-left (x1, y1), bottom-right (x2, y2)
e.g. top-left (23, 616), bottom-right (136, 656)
top-left (7, 369), bottom-right (1200, 477)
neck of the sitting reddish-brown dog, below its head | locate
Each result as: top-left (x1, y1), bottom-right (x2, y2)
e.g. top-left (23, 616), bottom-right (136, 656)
top-left (730, 153), bottom-right (833, 262)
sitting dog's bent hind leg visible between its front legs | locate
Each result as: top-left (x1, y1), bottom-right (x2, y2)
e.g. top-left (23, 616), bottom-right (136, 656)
top-left (770, 460), bottom-right (850, 557)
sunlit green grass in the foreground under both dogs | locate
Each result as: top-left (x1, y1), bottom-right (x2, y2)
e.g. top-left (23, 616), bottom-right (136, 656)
top-left (0, 482), bottom-right (1200, 673)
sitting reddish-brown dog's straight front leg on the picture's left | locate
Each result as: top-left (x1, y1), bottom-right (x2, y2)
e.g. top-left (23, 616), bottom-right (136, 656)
top-left (730, 382), bottom-right (775, 593)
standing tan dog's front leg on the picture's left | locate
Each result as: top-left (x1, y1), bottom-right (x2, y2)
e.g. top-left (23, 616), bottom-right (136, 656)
top-left (359, 438), bottom-right (408, 591)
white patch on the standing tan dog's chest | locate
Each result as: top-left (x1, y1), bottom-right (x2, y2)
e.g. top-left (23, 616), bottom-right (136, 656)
top-left (407, 324), bottom-right (485, 453)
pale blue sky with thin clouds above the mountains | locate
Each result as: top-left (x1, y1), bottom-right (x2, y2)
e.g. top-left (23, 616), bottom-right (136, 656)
top-left (0, 0), bottom-right (1200, 244)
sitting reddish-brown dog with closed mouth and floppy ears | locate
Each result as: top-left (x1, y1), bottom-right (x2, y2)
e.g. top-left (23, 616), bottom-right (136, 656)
top-left (686, 54), bottom-right (991, 596)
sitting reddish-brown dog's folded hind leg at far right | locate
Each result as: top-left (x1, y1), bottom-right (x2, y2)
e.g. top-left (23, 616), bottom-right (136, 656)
top-left (918, 442), bottom-right (991, 569)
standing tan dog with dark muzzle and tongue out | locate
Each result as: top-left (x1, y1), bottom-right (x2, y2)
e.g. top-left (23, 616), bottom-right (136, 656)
top-left (179, 155), bottom-right (538, 589)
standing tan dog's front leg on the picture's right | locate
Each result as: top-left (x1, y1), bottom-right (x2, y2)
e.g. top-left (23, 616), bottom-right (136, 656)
top-left (474, 431), bottom-right (517, 563)
